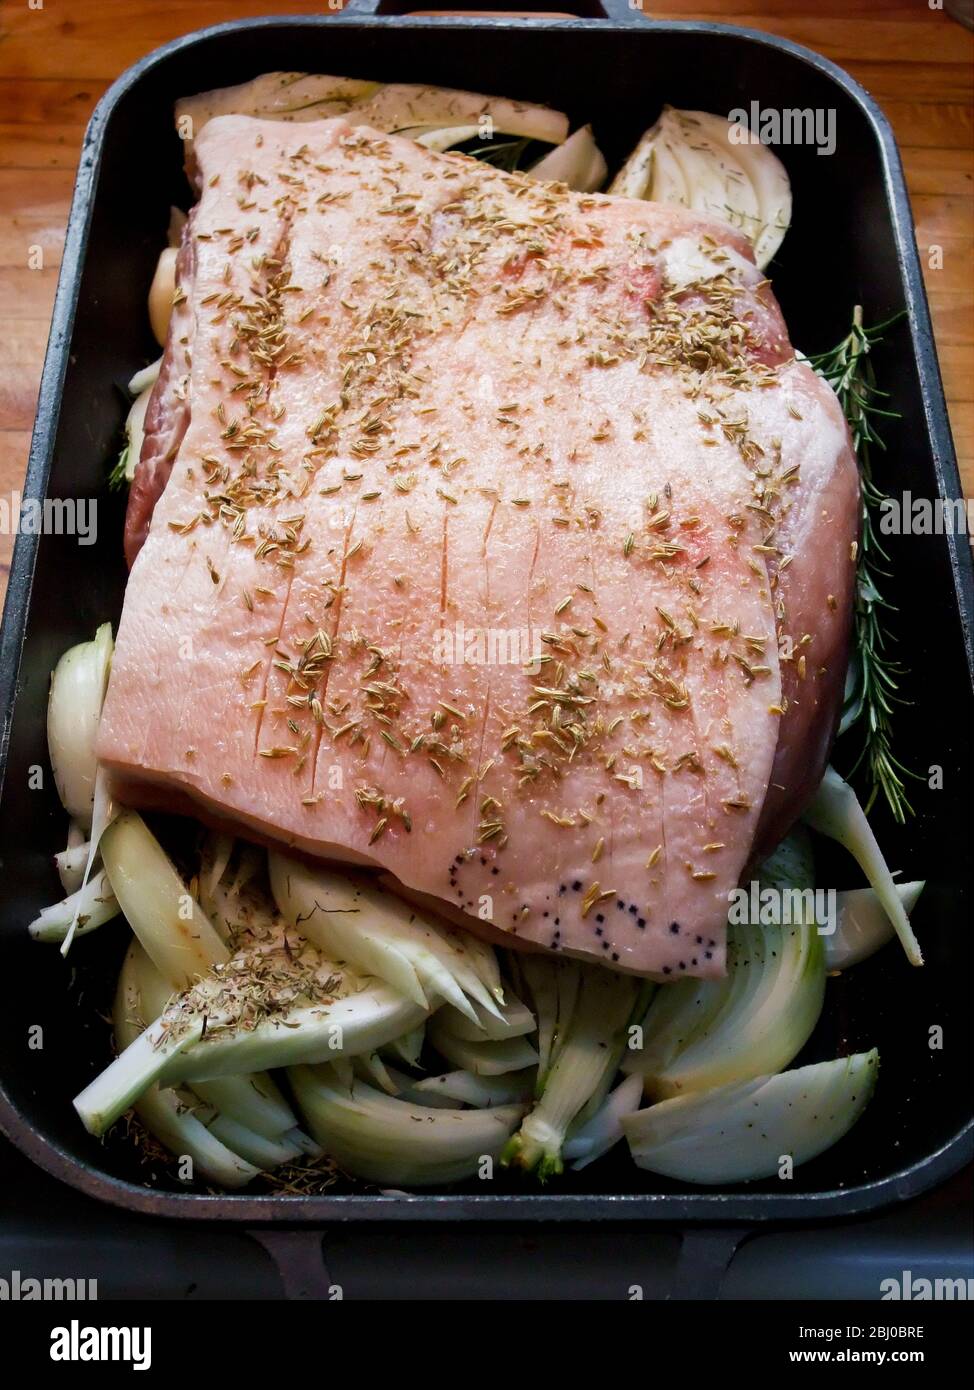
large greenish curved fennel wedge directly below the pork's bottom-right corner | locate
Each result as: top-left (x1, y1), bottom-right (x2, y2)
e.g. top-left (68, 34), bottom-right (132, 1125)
top-left (622, 831), bottom-right (825, 1099)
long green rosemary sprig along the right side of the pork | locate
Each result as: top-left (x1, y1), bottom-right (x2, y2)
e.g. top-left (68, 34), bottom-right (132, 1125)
top-left (809, 304), bottom-right (917, 826)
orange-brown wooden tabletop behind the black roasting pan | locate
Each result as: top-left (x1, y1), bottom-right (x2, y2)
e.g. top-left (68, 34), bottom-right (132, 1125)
top-left (0, 0), bottom-right (974, 598)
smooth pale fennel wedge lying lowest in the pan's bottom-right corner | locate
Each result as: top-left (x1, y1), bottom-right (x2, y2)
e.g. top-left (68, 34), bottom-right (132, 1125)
top-left (621, 1048), bottom-right (880, 1184)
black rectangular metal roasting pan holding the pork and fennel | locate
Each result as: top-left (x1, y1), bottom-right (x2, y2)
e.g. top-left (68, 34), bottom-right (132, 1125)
top-left (0, 0), bottom-right (974, 1223)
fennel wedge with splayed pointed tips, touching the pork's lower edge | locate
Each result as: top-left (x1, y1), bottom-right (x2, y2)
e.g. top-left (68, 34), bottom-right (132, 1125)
top-left (268, 852), bottom-right (503, 1023)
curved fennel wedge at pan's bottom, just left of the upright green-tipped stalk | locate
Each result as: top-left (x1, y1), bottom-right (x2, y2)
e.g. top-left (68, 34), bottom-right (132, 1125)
top-left (289, 1066), bottom-right (524, 1187)
